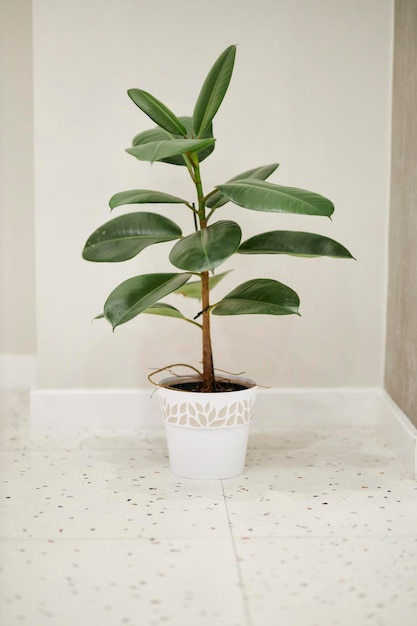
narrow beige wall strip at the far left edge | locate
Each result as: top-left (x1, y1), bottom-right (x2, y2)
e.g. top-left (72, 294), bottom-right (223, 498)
top-left (0, 0), bottom-right (35, 355)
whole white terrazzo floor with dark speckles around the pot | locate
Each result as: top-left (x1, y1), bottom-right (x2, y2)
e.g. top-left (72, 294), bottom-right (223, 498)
top-left (0, 391), bottom-right (417, 626)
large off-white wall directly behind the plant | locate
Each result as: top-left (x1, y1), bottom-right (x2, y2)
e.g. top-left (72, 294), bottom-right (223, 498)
top-left (34, 0), bottom-right (393, 388)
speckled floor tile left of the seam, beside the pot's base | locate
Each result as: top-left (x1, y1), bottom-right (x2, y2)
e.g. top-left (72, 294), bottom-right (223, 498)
top-left (0, 449), bottom-right (229, 539)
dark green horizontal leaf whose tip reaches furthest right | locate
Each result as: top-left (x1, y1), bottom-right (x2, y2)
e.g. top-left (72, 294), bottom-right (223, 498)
top-left (238, 230), bottom-right (353, 259)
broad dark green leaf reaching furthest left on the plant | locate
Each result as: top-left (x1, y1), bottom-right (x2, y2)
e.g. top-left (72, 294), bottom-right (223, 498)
top-left (83, 213), bottom-right (182, 263)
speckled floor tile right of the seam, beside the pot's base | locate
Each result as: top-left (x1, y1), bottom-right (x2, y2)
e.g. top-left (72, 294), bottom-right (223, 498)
top-left (224, 448), bottom-right (417, 537)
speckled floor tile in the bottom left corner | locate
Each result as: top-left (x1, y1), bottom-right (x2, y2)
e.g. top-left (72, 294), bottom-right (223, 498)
top-left (0, 539), bottom-right (245, 626)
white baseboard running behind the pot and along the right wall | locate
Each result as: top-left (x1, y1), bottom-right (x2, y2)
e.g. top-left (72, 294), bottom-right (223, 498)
top-left (31, 387), bottom-right (417, 478)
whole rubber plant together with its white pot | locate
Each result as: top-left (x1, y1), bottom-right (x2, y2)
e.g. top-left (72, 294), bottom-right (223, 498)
top-left (83, 45), bottom-right (352, 478)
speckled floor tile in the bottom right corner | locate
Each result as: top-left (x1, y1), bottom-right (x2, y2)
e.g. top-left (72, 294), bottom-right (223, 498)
top-left (232, 537), bottom-right (417, 626)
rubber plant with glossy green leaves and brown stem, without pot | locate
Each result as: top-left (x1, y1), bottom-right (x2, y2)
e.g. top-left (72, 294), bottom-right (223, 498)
top-left (83, 45), bottom-right (353, 392)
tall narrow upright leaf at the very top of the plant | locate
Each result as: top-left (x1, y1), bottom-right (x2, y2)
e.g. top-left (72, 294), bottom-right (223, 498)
top-left (193, 46), bottom-right (236, 137)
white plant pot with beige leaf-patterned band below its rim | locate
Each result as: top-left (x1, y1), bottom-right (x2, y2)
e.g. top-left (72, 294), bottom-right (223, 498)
top-left (158, 378), bottom-right (256, 479)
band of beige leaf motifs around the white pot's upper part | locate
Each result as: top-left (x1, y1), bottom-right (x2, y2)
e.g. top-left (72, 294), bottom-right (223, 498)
top-left (161, 393), bottom-right (255, 428)
